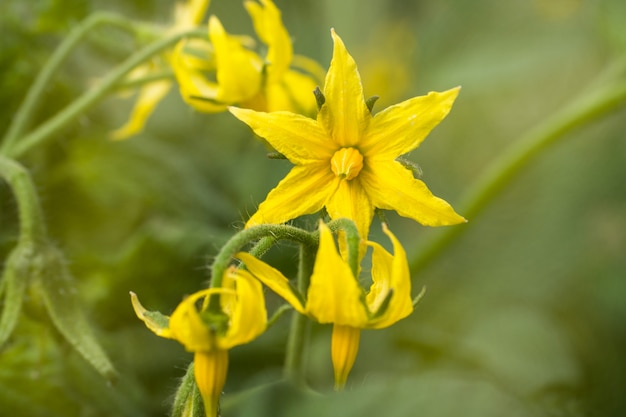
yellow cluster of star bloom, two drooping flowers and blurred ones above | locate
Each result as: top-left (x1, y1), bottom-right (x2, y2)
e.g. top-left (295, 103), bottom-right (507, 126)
top-left (132, 0), bottom-right (465, 416)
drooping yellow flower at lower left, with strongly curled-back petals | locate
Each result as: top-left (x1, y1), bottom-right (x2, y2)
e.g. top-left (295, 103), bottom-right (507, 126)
top-left (131, 267), bottom-right (267, 417)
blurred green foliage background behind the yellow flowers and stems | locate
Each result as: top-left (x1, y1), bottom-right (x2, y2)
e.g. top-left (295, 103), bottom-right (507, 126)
top-left (0, 0), bottom-right (626, 417)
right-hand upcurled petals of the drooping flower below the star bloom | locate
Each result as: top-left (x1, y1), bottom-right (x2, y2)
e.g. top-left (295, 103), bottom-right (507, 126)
top-left (366, 223), bottom-right (413, 329)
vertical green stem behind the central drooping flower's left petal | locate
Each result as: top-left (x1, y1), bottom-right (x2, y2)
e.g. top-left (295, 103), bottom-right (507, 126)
top-left (284, 245), bottom-right (316, 385)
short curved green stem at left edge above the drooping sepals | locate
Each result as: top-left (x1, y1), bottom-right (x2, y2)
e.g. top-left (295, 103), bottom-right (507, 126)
top-left (0, 155), bottom-right (47, 245)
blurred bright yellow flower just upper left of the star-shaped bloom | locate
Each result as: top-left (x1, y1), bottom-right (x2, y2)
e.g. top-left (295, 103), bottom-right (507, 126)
top-left (174, 0), bottom-right (323, 113)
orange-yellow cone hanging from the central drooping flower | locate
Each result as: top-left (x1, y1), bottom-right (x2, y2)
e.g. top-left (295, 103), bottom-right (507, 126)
top-left (330, 324), bottom-right (361, 391)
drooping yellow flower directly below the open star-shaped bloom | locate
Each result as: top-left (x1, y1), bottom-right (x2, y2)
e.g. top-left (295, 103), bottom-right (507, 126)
top-left (236, 223), bottom-right (414, 389)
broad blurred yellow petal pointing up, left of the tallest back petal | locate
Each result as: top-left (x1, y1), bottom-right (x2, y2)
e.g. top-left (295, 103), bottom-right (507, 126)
top-left (209, 16), bottom-right (263, 104)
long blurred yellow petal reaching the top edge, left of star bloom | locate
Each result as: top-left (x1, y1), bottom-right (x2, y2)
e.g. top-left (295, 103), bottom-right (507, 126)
top-left (244, 0), bottom-right (293, 84)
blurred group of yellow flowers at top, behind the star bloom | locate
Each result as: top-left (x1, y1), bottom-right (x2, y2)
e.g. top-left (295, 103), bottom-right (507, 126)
top-left (112, 0), bottom-right (324, 139)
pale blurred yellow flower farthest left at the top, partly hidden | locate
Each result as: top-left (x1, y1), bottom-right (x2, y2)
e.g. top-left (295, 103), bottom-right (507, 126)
top-left (111, 0), bottom-right (210, 140)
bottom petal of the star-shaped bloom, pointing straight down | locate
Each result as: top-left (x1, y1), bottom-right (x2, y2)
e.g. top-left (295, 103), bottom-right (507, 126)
top-left (326, 176), bottom-right (374, 240)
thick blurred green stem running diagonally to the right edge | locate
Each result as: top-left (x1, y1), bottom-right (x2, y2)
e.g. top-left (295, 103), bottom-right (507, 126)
top-left (410, 79), bottom-right (626, 273)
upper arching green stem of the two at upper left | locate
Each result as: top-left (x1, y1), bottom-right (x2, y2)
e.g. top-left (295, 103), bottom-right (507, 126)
top-left (1, 12), bottom-right (134, 152)
